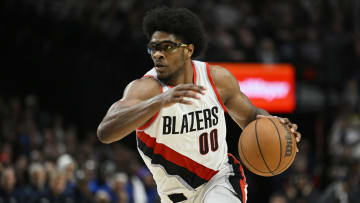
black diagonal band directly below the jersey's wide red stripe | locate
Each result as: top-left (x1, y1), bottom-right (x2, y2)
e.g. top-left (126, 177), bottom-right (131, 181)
top-left (136, 137), bottom-right (207, 189)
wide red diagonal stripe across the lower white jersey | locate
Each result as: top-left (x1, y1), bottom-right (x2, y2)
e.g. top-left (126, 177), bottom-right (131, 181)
top-left (136, 131), bottom-right (218, 181)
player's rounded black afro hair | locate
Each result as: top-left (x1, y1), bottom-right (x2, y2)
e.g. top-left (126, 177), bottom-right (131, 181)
top-left (143, 7), bottom-right (207, 57)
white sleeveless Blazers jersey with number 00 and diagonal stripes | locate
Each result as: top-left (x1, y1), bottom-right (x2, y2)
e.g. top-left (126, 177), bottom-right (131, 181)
top-left (136, 61), bottom-right (248, 202)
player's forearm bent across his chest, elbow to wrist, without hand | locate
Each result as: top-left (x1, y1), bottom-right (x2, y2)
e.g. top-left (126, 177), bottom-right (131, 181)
top-left (97, 96), bottom-right (163, 143)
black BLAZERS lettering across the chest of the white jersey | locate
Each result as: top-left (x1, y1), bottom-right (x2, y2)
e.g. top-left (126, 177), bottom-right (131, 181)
top-left (162, 106), bottom-right (219, 135)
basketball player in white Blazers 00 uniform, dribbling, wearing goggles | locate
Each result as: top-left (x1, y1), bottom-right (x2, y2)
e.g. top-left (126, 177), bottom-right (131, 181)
top-left (98, 8), bottom-right (300, 203)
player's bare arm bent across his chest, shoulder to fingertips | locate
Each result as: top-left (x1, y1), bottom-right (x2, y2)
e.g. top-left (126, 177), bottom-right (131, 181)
top-left (97, 78), bottom-right (204, 143)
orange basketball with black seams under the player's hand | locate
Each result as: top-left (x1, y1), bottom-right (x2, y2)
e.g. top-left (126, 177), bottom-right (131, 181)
top-left (238, 118), bottom-right (296, 176)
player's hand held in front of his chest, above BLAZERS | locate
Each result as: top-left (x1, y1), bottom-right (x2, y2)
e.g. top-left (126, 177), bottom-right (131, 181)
top-left (161, 84), bottom-right (206, 107)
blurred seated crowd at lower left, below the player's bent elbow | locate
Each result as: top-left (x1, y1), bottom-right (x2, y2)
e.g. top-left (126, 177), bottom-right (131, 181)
top-left (0, 95), bottom-right (157, 203)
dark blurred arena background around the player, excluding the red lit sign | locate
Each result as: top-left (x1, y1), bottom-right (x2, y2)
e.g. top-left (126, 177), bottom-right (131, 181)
top-left (0, 0), bottom-right (360, 202)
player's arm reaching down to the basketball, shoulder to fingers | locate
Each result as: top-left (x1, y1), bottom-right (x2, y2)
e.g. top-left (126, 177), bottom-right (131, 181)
top-left (210, 66), bottom-right (301, 142)
